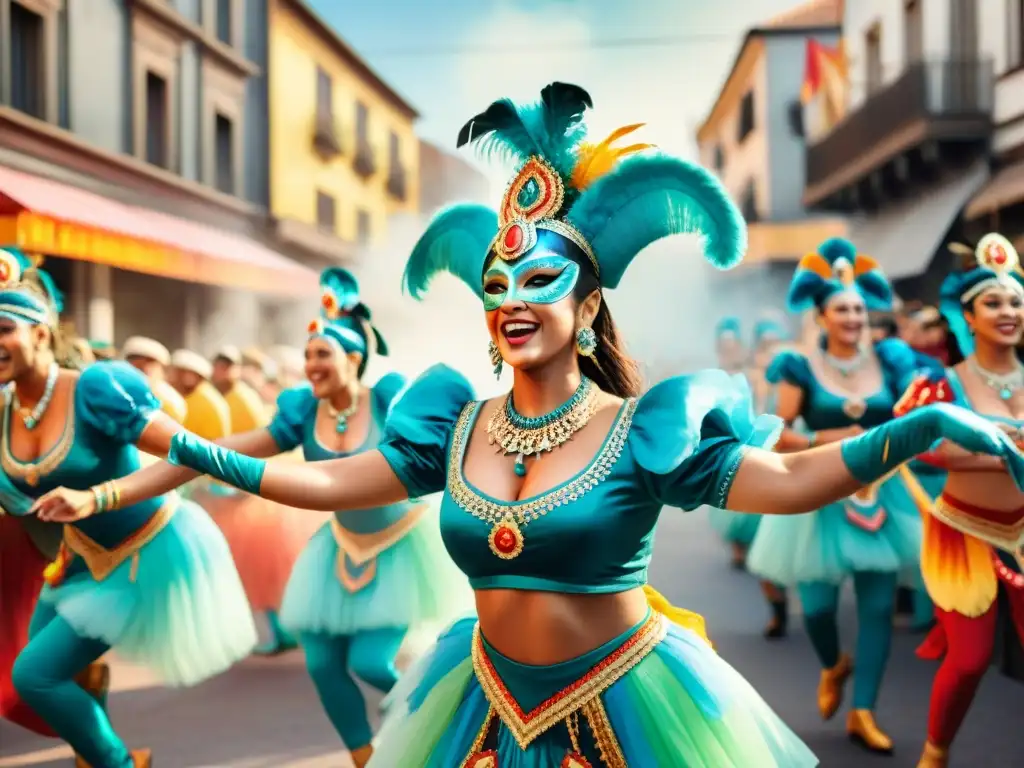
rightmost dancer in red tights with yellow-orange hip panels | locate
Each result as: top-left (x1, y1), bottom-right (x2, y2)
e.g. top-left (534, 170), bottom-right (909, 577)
top-left (897, 233), bottom-right (1024, 768)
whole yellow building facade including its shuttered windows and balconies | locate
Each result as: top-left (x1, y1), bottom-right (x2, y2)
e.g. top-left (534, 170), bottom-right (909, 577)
top-left (269, 0), bottom-right (420, 262)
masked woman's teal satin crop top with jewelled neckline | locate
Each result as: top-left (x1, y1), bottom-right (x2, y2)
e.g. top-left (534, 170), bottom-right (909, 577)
top-left (378, 366), bottom-right (781, 593)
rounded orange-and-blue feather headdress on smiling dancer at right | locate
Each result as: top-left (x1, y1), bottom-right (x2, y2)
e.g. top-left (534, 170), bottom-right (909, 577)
top-left (785, 238), bottom-right (893, 312)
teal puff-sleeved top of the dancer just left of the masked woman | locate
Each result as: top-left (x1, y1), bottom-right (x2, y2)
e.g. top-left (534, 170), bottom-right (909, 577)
top-left (267, 374), bottom-right (415, 534)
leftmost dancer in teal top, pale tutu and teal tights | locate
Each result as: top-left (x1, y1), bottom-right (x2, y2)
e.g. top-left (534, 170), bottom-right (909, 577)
top-left (0, 260), bottom-right (256, 768)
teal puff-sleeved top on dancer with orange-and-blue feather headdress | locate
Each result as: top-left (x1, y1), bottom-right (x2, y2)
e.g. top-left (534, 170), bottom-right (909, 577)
top-left (765, 339), bottom-right (920, 432)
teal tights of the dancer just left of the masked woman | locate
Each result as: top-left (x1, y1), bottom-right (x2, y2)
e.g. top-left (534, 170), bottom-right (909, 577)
top-left (300, 628), bottom-right (406, 750)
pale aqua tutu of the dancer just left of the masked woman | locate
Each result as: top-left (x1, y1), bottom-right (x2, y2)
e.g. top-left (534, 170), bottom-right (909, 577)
top-left (281, 499), bottom-right (472, 635)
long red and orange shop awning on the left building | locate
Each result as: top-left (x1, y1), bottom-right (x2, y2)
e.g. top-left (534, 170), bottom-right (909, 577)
top-left (0, 167), bottom-right (318, 295)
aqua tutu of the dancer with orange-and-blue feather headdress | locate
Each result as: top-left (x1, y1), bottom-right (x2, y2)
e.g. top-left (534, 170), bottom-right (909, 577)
top-left (746, 475), bottom-right (922, 586)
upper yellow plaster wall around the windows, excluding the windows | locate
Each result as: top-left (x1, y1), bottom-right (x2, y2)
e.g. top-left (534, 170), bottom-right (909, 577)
top-left (268, 0), bottom-right (420, 245)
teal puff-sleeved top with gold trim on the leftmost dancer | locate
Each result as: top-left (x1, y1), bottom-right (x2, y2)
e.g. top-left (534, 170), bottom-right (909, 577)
top-left (0, 361), bottom-right (164, 549)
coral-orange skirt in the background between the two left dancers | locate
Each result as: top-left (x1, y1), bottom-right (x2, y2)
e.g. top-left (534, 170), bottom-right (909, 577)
top-left (190, 481), bottom-right (328, 611)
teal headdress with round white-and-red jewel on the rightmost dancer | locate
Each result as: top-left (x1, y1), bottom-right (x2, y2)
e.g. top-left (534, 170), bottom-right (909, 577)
top-left (939, 232), bottom-right (1024, 355)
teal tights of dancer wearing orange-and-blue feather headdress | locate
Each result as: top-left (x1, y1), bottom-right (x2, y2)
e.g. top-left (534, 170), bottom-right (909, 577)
top-left (798, 571), bottom-right (897, 710)
